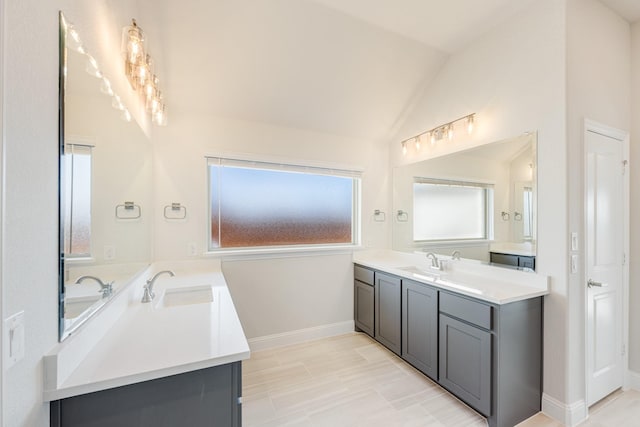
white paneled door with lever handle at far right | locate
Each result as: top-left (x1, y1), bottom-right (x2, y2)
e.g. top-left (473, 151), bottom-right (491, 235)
top-left (584, 128), bottom-right (626, 405)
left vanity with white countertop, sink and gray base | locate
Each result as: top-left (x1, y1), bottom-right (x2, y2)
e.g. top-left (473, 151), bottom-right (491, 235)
top-left (44, 261), bottom-right (250, 427)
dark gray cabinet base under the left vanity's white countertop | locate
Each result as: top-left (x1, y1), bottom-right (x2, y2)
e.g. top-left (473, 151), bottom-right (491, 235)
top-left (51, 362), bottom-right (242, 427)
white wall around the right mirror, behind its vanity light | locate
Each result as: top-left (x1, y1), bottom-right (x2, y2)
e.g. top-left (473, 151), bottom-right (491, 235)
top-left (390, 0), bottom-right (570, 420)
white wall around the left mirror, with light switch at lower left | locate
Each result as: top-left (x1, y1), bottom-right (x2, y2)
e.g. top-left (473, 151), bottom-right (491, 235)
top-left (2, 0), bottom-right (153, 426)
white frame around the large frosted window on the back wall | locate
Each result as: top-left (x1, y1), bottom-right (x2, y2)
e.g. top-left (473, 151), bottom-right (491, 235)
top-left (205, 155), bottom-right (363, 256)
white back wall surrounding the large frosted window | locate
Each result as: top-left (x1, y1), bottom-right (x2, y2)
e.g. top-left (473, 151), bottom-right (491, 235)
top-left (154, 114), bottom-right (390, 338)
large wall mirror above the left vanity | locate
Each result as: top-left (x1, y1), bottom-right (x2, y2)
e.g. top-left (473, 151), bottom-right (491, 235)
top-left (59, 13), bottom-right (152, 340)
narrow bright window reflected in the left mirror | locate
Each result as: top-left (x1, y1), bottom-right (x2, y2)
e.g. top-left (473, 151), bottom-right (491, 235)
top-left (62, 144), bottom-right (91, 257)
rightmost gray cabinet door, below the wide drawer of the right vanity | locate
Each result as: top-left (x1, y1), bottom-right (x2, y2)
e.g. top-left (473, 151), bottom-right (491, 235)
top-left (439, 314), bottom-right (491, 416)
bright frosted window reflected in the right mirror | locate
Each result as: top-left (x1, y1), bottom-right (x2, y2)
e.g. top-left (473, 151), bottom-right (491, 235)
top-left (413, 180), bottom-right (493, 241)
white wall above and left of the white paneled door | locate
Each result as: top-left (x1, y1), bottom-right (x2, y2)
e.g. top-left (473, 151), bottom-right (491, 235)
top-left (565, 0), bottom-right (638, 412)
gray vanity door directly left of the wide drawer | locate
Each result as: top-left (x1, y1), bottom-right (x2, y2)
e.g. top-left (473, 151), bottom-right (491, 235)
top-left (402, 280), bottom-right (438, 380)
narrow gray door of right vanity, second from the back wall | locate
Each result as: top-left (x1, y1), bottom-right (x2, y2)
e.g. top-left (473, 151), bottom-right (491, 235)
top-left (375, 271), bottom-right (402, 355)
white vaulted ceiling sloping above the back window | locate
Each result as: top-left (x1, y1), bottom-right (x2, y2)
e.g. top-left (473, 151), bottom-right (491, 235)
top-left (146, 0), bottom-right (640, 144)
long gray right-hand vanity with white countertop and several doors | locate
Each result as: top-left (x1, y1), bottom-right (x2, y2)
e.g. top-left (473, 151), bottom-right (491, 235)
top-left (354, 251), bottom-right (548, 427)
